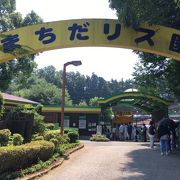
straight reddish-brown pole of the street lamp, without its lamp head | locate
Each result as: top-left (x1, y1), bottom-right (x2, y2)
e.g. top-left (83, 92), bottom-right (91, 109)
top-left (61, 64), bottom-right (66, 135)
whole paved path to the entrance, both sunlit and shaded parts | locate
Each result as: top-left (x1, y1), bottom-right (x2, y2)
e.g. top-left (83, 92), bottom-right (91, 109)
top-left (39, 141), bottom-right (180, 180)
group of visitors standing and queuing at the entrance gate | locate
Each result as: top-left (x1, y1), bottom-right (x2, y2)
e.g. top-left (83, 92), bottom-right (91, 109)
top-left (103, 118), bottom-right (176, 155)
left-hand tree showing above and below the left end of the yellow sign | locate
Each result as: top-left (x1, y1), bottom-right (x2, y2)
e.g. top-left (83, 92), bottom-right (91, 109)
top-left (0, 0), bottom-right (42, 91)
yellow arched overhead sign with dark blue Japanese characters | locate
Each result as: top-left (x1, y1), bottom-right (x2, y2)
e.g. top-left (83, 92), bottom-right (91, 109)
top-left (0, 19), bottom-right (180, 62)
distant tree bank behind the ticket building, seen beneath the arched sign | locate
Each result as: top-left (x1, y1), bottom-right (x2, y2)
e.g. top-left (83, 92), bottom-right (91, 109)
top-left (8, 66), bottom-right (133, 105)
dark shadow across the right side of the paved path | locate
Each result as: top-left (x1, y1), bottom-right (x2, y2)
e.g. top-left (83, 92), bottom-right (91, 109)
top-left (117, 143), bottom-right (180, 180)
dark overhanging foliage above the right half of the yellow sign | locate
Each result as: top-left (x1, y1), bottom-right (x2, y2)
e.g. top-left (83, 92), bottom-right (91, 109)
top-left (109, 0), bottom-right (180, 28)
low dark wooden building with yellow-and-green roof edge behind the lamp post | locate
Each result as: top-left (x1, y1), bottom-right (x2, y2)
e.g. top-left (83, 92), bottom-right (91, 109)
top-left (42, 105), bottom-right (101, 136)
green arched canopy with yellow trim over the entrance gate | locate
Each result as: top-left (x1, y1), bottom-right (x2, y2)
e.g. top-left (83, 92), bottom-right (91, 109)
top-left (98, 92), bottom-right (172, 113)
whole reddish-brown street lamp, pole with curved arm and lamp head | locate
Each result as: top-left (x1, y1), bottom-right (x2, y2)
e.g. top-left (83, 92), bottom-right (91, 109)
top-left (61, 61), bottom-right (82, 135)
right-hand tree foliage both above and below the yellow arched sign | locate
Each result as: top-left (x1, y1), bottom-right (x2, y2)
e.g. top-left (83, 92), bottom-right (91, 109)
top-left (109, 0), bottom-right (180, 99)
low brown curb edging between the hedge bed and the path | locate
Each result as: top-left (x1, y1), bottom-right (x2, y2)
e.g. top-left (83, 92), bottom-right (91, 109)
top-left (20, 144), bottom-right (84, 180)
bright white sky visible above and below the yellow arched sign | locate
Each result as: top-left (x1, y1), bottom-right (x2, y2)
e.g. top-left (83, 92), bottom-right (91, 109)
top-left (16, 0), bottom-right (138, 81)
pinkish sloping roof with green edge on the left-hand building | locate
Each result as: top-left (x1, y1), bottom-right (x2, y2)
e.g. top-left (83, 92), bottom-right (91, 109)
top-left (1, 93), bottom-right (39, 104)
